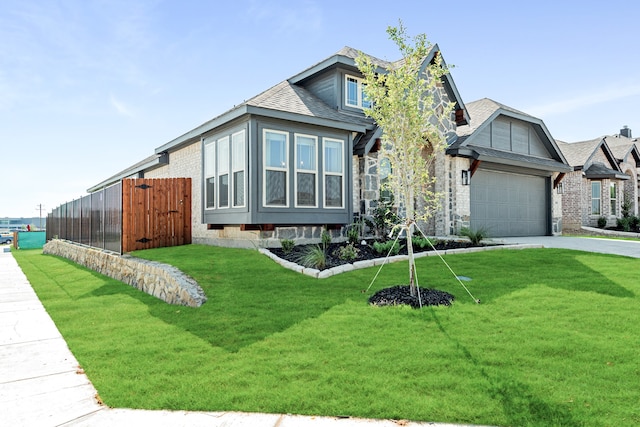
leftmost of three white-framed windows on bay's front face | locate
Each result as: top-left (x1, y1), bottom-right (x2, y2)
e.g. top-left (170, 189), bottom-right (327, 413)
top-left (263, 129), bottom-right (289, 207)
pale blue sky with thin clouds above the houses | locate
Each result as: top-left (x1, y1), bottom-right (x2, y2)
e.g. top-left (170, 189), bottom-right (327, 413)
top-left (0, 0), bottom-right (640, 217)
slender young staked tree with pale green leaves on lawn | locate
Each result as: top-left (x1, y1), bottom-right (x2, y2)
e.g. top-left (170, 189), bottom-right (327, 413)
top-left (356, 22), bottom-right (453, 296)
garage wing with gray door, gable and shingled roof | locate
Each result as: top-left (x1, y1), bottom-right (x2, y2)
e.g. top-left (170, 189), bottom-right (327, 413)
top-left (446, 98), bottom-right (571, 236)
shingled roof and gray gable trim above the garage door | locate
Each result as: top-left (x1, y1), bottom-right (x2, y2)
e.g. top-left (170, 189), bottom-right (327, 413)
top-left (447, 98), bottom-right (571, 172)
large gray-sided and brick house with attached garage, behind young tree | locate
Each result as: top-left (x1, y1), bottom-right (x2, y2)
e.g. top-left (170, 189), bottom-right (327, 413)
top-left (88, 45), bottom-right (569, 247)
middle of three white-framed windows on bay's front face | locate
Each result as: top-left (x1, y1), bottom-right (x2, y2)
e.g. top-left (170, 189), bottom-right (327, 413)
top-left (295, 134), bottom-right (318, 207)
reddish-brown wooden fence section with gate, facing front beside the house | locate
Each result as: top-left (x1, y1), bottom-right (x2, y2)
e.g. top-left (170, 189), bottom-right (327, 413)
top-left (122, 178), bottom-right (191, 253)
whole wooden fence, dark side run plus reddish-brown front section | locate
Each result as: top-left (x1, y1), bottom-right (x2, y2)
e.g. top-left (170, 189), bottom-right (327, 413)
top-left (47, 178), bottom-right (191, 253)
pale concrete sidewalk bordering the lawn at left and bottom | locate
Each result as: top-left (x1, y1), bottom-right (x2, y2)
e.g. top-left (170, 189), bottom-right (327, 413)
top-left (0, 246), bottom-right (480, 427)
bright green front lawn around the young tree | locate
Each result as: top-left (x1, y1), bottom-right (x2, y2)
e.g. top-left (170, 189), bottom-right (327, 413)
top-left (14, 245), bottom-right (640, 426)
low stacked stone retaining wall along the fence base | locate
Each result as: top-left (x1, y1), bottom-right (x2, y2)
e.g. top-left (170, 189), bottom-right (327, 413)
top-left (42, 240), bottom-right (207, 307)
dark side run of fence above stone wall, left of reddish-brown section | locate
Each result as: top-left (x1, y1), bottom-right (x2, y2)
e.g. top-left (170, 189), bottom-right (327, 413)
top-left (47, 182), bottom-right (122, 253)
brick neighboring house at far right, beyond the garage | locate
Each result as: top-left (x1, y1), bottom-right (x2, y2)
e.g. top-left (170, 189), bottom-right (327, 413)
top-left (558, 127), bottom-right (640, 231)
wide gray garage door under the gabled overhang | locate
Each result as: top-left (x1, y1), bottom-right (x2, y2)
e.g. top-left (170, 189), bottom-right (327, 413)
top-left (471, 169), bottom-right (548, 237)
